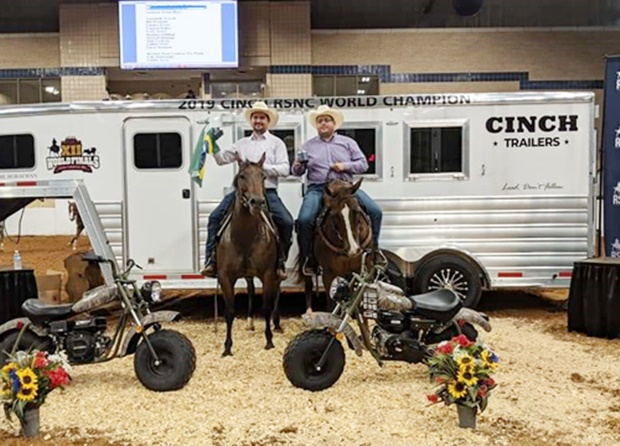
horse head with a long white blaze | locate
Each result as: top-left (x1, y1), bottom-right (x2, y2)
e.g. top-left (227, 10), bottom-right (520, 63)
top-left (321, 178), bottom-right (372, 257)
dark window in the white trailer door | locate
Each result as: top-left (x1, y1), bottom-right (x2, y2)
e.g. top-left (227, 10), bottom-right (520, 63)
top-left (133, 133), bottom-right (183, 169)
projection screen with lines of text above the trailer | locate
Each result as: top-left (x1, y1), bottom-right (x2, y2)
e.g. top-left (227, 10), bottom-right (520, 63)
top-left (118, 0), bottom-right (239, 70)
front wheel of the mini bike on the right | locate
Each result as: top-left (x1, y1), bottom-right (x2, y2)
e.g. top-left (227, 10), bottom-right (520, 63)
top-left (283, 330), bottom-right (345, 392)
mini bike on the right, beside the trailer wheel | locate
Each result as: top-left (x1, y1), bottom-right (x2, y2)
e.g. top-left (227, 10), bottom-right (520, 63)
top-left (283, 253), bottom-right (491, 391)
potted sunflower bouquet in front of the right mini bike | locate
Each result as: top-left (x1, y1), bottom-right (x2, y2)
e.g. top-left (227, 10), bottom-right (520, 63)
top-left (427, 335), bottom-right (499, 427)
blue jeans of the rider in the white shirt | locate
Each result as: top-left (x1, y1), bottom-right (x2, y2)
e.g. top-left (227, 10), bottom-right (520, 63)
top-left (205, 189), bottom-right (294, 262)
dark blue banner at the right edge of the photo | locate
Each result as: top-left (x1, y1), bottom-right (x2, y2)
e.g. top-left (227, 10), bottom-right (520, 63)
top-left (603, 56), bottom-right (620, 258)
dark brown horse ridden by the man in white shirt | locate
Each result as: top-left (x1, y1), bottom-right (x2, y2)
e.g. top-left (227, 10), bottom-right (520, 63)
top-left (216, 154), bottom-right (280, 356)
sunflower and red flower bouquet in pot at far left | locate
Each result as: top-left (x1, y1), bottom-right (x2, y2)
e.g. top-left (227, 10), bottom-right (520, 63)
top-left (0, 350), bottom-right (71, 437)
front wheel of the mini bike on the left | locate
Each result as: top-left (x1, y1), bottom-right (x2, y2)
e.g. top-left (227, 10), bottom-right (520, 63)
top-left (133, 330), bottom-right (196, 392)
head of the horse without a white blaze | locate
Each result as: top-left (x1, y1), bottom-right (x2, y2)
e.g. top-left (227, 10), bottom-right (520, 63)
top-left (233, 153), bottom-right (267, 215)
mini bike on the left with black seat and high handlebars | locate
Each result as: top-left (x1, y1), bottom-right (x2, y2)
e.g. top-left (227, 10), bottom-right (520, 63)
top-left (0, 253), bottom-right (196, 391)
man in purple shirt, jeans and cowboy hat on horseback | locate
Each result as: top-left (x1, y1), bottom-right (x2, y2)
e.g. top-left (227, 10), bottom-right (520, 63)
top-left (292, 105), bottom-right (383, 274)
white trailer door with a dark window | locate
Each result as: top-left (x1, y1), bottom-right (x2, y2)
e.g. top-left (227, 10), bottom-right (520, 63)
top-left (124, 117), bottom-right (195, 273)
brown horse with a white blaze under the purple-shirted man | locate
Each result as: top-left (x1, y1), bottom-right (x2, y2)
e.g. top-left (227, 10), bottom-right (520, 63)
top-left (302, 179), bottom-right (372, 312)
